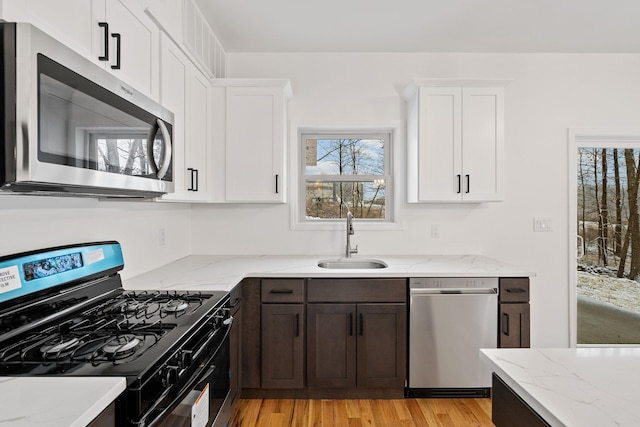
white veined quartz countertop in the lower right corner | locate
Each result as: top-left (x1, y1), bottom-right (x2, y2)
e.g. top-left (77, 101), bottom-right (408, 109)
top-left (480, 347), bottom-right (640, 427)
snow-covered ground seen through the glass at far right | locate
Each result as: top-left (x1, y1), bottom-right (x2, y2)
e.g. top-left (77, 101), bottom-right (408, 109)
top-left (577, 271), bottom-right (640, 313)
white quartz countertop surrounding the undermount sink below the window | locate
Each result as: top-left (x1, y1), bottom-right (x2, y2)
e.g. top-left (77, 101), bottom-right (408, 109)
top-left (123, 255), bottom-right (533, 291)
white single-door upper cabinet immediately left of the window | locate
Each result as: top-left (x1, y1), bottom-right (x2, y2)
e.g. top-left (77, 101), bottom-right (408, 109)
top-left (212, 79), bottom-right (292, 203)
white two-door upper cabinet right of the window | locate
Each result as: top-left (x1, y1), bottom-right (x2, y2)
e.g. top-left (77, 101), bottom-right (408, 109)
top-left (403, 79), bottom-right (508, 203)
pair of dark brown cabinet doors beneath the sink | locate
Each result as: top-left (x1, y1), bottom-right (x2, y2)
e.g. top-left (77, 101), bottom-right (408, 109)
top-left (307, 303), bottom-right (406, 388)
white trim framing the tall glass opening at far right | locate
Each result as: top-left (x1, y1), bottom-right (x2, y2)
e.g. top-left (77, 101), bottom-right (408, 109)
top-left (567, 128), bottom-right (640, 347)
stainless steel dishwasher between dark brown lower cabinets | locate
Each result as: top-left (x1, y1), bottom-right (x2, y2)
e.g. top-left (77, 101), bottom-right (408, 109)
top-left (406, 278), bottom-right (498, 397)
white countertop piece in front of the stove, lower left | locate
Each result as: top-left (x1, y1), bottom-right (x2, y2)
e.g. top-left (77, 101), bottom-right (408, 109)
top-left (0, 377), bottom-right (126, 427)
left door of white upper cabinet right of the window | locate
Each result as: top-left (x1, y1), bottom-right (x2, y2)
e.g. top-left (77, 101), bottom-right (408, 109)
top-left (416, 87), bottom-right (462, 201)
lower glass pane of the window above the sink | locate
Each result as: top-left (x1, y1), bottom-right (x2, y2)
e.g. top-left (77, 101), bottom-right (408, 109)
top-left (305, 179), bottom-right (386, 220)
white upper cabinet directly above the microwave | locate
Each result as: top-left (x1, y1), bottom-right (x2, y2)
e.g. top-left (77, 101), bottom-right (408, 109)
top-left (2, 0), bottom-right (160, 99)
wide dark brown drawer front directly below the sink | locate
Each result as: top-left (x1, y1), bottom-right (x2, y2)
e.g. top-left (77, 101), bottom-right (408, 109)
top-left (307, 279), bottom-right (407, 303)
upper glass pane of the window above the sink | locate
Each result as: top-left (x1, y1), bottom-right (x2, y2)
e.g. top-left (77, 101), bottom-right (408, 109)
top-left (305, 138), bottom-right (385, 175)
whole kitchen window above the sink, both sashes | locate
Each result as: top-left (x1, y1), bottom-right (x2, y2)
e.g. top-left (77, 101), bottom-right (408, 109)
top-left (299, 131), bottom-right (393, 223)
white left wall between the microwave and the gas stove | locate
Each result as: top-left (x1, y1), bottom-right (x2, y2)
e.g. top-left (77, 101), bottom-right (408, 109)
top-left (0, 195), bottom-right (191, 279)
